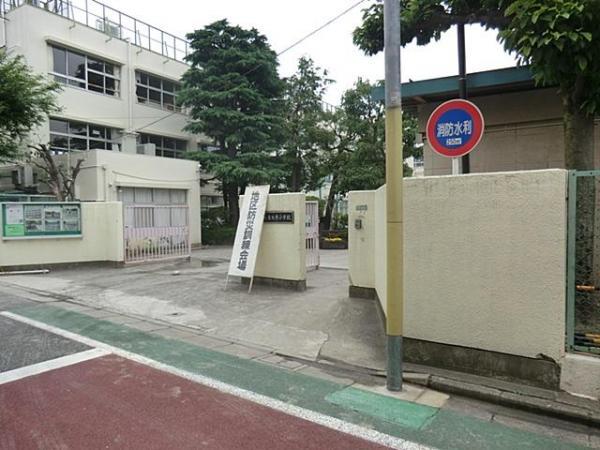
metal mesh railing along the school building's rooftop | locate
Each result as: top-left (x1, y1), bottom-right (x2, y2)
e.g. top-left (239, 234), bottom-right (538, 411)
top-left (0, 0), bottom-right (189, 62)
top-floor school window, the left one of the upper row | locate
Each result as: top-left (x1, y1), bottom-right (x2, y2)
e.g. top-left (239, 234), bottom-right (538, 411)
top-left (52, 46), bottom-right (120, 97)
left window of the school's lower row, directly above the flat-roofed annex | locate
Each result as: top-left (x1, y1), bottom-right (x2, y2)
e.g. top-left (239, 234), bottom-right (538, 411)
top-left (50, 119), bottom-right (118, 155)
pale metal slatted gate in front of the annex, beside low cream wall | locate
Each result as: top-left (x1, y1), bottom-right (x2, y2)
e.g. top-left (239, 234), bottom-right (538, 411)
top-left (123, 205), bottom-right (192, 263)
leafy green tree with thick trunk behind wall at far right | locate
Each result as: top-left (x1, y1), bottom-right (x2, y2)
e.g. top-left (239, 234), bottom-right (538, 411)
top-left (500, 0), bottom-right (600, 169)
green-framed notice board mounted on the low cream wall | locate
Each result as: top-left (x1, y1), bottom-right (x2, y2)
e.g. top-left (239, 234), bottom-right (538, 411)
top-left (1, 202), bottom-right (82, 239)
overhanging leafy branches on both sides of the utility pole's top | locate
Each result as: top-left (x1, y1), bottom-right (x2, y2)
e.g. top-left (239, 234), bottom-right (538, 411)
top-left (353, 0), bottom-right (513, 55)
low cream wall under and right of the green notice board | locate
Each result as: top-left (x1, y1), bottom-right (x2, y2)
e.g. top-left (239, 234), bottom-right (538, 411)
top-left (0, 202), bottom-right (123, 267)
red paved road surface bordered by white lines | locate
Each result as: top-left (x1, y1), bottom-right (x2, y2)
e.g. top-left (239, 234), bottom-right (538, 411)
top-left (0, 355), bottom-right (390, 450)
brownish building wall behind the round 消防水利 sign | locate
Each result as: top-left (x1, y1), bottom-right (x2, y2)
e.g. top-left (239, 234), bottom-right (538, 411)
top-left (418, 89), bottom-right (600, 176)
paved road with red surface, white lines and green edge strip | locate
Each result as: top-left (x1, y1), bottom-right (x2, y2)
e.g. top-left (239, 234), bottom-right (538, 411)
top-left (0, 290), bottom-right (600, 450)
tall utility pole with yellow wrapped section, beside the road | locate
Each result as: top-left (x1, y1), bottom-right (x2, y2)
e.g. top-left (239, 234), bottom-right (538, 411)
top-left (383, 0), bottom-right (404, 391)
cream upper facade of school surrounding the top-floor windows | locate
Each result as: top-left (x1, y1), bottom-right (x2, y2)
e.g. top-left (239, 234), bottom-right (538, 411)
top-left (2, 5), bottom-right (198, 148)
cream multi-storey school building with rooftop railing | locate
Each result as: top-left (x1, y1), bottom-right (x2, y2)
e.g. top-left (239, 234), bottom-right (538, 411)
top-left (0, 0), bottom-right (207, 243)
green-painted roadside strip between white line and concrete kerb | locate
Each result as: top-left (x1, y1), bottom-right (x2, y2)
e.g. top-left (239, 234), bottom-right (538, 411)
top-left (3, 302), bottom-right (600, 449)
